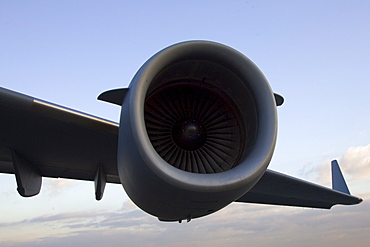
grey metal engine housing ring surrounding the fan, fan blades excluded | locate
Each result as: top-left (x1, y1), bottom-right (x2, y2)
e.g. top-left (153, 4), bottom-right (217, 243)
top-left (117, 41), bottom-right (277, 221)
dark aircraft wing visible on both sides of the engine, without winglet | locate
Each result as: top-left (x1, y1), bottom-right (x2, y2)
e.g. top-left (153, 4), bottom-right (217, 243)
top-left (0, 88), bottom-right (361, 208)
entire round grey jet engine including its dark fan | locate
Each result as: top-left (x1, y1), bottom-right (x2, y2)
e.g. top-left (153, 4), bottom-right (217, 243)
top-left (117, 41), bottom-right (277, 221)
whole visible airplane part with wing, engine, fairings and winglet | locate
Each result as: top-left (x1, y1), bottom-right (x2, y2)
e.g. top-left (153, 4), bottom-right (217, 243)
top-left (0, 41), bottom-right (362, 223)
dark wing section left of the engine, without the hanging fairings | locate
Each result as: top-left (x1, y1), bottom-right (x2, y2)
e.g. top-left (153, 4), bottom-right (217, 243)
top-left (0, 87), bottom-right (119, 183)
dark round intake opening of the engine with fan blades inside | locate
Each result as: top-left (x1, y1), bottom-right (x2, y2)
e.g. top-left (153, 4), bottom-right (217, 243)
top-left (144, 61), bottom-right (258, 173)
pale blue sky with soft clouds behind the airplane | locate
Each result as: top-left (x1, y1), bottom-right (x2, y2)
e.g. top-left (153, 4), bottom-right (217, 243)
top-left (0, 0), bottom-right (370, 247)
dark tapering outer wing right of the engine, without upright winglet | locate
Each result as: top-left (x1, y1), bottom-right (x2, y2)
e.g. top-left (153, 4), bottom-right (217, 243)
top-left (236, 170), bottom-right (362, 209)
